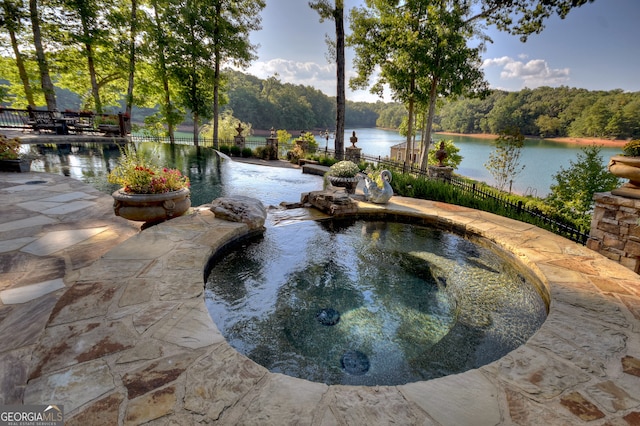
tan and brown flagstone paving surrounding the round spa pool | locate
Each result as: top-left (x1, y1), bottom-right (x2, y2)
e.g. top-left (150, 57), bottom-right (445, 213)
top-left (0, 174), bottom-right (640, 425)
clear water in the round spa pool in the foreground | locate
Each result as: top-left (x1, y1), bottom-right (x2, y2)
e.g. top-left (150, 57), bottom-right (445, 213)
top-left (205, 221), bottom-right (547, 385)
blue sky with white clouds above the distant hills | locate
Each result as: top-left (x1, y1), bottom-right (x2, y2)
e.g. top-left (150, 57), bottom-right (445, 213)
top-left (242, 0), bottom-right (640, 102)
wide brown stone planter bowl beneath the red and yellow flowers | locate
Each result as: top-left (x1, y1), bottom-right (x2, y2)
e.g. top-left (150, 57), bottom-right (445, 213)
top-left (111, 188), bottom-right (191, 222)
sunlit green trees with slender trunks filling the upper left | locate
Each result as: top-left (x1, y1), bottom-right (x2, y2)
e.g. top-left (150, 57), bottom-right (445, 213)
top-left (0, 0), bottom-right (265, 143)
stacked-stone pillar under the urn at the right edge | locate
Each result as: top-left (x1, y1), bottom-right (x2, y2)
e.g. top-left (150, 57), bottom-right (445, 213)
top-left (587, 192), bottom-right (640, 273)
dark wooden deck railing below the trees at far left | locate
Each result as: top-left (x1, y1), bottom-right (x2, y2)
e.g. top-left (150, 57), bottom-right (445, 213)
top-left (0, 107), bottom-right (131, 137)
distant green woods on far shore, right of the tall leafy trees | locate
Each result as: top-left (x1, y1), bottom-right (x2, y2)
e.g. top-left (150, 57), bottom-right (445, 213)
top-left (436, 86), bottom-right (640, 139)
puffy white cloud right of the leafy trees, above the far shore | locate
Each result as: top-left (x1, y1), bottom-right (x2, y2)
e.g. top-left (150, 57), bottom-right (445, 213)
top-left (482, 55), bottom-right (570, 89)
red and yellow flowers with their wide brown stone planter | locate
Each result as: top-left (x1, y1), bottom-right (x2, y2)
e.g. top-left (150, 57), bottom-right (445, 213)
top-left (108, 147), bottom-right (191, 222)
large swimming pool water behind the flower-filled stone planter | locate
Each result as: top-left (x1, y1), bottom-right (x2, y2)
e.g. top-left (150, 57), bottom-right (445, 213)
top-left (28, 142), bottom-right (322, 206)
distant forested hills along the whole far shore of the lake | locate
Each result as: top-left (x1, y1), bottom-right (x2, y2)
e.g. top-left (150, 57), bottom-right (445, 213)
top-left (223, 71), bottom-right (640, 139)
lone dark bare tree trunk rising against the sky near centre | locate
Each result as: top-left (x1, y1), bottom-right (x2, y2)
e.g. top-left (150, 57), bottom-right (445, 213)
top-left (334, 0), bottom-right (346, 160)
